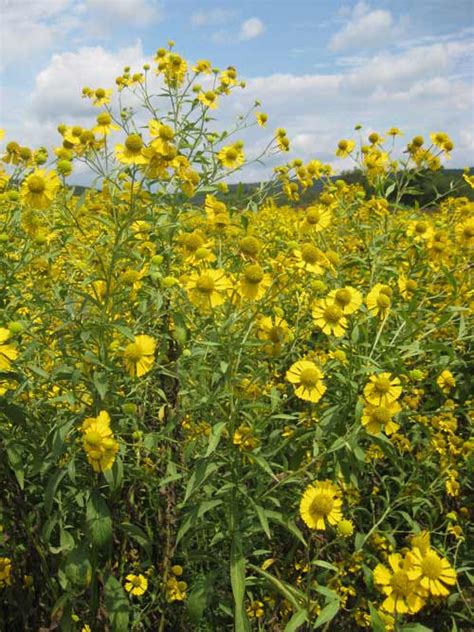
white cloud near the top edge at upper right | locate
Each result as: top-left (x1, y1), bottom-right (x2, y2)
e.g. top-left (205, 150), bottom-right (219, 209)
top-left (329, 2), bottom-right (401, 51)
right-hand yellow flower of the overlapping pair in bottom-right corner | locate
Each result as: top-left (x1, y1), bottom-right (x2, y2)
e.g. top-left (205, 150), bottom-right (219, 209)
top-left (408, 548), bottom-right (456, 597)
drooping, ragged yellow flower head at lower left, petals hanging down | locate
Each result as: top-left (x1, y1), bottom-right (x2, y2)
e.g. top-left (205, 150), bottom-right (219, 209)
top-left (81, 410), bottom-right (119, 472)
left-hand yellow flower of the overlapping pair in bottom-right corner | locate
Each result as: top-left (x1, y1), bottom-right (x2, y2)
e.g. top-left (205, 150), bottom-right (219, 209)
top-left (374, 553), bottom-right (425, 614)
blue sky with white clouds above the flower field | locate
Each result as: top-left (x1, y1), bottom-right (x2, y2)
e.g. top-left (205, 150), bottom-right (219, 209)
top-left (0, 0), bottom-right (474, 181)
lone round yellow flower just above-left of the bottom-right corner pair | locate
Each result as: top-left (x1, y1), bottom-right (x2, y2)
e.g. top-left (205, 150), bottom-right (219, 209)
top-left (300, 481), bottom-right (342, 531)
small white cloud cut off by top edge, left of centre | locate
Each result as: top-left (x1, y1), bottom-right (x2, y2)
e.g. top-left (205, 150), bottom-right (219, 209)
top-left (86, 0), bottom-right (162, 28)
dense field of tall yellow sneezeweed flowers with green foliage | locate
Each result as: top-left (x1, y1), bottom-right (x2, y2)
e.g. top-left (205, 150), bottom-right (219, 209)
top-left (0, 43), bottom-right (474, 632)
